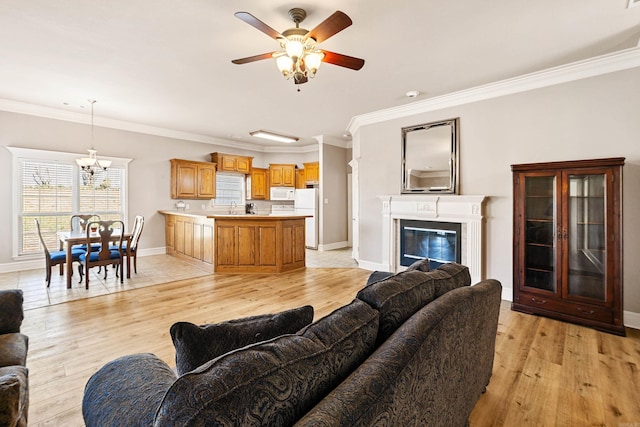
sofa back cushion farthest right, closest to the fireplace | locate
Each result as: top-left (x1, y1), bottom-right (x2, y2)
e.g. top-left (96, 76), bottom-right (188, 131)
top-left (357, 263), bottom-right (471, 345)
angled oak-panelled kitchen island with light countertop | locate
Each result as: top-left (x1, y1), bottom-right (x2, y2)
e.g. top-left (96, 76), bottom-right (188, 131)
top-left (158, 210), bottom-right (307, 273)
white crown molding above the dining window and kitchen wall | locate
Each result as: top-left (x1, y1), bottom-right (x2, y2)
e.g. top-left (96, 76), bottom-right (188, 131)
top-left (0, 99), bottom-right (318, 153)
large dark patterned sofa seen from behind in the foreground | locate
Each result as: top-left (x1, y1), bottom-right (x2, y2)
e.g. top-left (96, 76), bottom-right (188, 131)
top-left (83, 264), bottom-right (501, 427)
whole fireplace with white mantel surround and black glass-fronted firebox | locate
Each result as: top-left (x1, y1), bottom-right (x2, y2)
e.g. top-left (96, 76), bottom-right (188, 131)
top-left (375, 194), bottom-right (486, 283)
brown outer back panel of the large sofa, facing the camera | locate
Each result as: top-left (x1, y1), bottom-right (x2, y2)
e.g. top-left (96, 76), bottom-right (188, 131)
top-left (296, 280), bottom-right (502, 426)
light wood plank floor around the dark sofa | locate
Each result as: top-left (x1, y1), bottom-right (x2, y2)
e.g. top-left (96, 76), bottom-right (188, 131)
top-left (0, 254), bottom-right (640, 427)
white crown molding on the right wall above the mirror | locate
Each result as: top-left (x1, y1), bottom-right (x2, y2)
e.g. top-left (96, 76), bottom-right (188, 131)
top-left (347, 47), bottom-right (640, 134)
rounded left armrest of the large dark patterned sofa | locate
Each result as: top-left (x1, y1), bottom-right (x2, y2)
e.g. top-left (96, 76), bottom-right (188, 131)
top-left (82, 353), bottom-right (177, 427)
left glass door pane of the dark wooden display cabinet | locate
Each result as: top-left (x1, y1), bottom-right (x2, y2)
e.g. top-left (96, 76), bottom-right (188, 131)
top-left (524, 175), bottom-right (557, 292)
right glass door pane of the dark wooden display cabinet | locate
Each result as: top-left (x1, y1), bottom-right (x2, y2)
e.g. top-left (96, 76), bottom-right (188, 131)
top-left (566, 174), bottom-right (607, 301)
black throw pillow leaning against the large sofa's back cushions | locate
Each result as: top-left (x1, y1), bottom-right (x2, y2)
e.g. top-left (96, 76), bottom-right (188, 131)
top-left (170, 305), bottom-right (313, 375)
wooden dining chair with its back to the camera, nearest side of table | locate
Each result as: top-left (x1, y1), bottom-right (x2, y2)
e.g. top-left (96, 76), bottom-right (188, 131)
top-left (78, 220), bottom-right (124, 289)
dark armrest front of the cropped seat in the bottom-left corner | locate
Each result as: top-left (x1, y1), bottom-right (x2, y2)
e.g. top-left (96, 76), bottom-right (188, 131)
top-left (0, 366), bottom-right (29, 426)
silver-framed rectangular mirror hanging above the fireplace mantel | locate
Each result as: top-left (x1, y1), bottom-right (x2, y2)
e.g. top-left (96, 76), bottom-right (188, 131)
top-left (402, 118), bottom-right (459, 194)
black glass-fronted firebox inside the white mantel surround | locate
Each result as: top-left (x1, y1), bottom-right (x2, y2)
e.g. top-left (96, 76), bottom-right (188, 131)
top-left (400, 219), bottom-right (462, 270)
